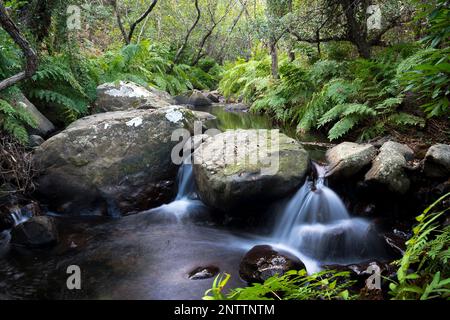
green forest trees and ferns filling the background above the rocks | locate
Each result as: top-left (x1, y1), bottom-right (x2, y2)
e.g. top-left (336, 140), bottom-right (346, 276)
top-left (0, 0), bottom-right (450, 142)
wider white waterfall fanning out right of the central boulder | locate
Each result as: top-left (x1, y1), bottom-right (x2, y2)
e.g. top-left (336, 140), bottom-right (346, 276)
top-left (273, 165), bottom-right (382, 263)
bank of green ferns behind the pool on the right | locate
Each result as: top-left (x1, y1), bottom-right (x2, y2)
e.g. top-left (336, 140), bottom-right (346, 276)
top-left (220, 44), bottom-right (425, 141)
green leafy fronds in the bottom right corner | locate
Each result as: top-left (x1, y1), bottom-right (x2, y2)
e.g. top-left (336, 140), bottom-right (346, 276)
top-left (390, 194), bottom-right (450, 300)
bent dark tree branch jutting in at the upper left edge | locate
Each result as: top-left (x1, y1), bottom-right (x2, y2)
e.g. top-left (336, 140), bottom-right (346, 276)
top-left (0, 1), bottom-right (38, 90)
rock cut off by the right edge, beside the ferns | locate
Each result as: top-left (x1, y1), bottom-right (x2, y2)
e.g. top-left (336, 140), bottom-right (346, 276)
top-left (424, 144), bottom-right (450, 180)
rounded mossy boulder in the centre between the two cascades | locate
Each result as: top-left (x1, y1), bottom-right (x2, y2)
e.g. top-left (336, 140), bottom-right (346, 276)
top-left (194, 130), bottom-right (310, 211)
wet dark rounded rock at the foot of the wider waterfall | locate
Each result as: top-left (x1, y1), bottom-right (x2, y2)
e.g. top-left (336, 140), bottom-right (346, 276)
top-left (239, 245), bottom-right (305, 283)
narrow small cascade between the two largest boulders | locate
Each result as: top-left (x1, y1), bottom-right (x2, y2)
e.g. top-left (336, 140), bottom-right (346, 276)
top-left (148, 161), bottom-right (206, 221)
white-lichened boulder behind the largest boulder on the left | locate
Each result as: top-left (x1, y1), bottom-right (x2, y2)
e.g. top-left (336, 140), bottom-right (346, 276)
top-left (96, 81), bottom-right (174, 112)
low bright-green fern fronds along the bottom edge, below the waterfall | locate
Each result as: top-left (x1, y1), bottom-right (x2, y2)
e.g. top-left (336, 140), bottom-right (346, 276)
top-left (203, 270), bottom-right (355, 300)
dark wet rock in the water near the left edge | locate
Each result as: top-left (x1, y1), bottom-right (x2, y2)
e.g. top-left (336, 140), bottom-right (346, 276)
top-left (11, 216), bottom-right (58, 248)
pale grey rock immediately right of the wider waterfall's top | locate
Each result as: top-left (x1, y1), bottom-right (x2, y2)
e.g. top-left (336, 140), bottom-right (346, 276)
top-left (326, 142), bottom-right (377, 180)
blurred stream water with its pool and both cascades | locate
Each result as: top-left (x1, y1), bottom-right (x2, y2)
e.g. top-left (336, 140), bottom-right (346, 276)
top-left (0, 106), bottom-right (384, 300)
